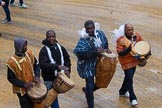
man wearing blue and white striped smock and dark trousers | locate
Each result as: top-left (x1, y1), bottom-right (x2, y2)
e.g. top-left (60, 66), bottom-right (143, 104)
top-left (73, 20), bottom-right (109, 108)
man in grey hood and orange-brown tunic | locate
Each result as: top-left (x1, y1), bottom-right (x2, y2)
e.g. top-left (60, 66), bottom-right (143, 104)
top-left (7, 38), bottom-right (40, 108)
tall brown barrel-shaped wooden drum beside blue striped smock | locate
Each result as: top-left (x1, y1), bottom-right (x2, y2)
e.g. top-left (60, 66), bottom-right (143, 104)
top-left (96, 52), bottom-right (117, 88)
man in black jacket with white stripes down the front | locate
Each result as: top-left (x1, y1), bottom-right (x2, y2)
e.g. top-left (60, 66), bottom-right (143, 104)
top-left (39, 30), bottom-right (71, 108)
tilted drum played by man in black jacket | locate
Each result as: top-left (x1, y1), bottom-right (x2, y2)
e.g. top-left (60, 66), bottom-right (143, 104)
top-left (53, 73), bottom-right (74, 93)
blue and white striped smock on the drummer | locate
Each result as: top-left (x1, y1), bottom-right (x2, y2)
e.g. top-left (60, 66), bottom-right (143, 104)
top-left (73, 30), bottom-right (108, 78)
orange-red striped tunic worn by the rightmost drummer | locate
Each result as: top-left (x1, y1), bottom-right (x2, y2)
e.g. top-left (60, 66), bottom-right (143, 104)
top-left (116, 33), bottom-right (142, 70)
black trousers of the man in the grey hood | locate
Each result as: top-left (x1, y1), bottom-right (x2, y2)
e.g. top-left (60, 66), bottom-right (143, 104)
top-left (17, 93), bottom-right (33, 108)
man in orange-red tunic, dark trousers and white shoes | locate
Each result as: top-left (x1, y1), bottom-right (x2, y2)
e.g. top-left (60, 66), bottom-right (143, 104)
top-left (116, 23), bottom-right (151, 106)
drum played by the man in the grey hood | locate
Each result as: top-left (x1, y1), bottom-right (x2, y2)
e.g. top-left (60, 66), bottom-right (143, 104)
top-left (27, 82), bottom-right (47, 103)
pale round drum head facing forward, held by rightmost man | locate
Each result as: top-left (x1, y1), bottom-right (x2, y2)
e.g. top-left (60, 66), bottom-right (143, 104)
top-left (134, 41), bottom-right (150, 55)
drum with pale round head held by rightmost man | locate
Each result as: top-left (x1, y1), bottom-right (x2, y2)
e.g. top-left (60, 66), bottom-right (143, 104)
top-left (134, 41), bottom-right (151, 67)
